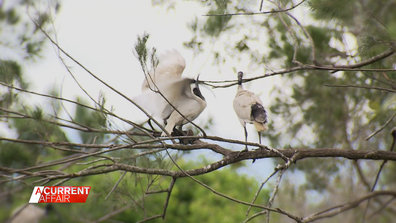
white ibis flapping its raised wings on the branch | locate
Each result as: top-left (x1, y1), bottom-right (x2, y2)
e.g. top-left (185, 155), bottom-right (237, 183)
top-left (134, 50), bottom-right (206, 136)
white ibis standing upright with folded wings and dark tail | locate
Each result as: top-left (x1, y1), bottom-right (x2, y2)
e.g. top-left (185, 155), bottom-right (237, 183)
top-left (233, 71), bottom-right (267, 151)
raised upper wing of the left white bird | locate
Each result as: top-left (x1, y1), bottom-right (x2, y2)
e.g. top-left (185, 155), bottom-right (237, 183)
top-left (142, 49), bottom-right (186, 91)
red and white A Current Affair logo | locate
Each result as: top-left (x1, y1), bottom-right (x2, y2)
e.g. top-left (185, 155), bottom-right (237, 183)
top-left (29, 186), bottom-right (91, 203)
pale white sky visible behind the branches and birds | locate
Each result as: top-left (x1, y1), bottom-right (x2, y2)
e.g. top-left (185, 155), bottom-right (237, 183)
top-left (21, 0), bottom-right (277, 181)
